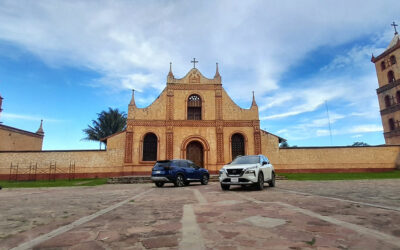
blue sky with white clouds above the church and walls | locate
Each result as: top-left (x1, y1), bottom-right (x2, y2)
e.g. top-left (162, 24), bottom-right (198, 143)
top-left (0, 0), bottom-right (400, 150)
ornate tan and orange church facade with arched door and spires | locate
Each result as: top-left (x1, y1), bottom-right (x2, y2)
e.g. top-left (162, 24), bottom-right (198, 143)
top-left (105, 64), bottom-right (284, 174)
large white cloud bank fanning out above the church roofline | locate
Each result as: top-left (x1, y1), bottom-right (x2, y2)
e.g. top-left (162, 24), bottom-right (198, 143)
top-left (0, 0), bottom-right (399, 94)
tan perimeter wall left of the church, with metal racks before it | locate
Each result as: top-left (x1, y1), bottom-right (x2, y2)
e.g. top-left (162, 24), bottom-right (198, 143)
top-left (0, 149), bottom-right (128, 180)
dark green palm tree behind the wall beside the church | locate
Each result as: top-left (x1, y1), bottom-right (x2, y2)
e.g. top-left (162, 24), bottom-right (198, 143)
top-left (83, 108), bottom-right (126, 148)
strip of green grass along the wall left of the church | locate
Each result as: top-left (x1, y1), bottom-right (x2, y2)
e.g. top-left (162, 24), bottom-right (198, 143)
top-left (0, 178), bottom-right (107, 188)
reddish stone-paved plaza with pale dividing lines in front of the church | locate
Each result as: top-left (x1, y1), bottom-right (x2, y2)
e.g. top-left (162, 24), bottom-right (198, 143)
top-left (0, 180), bottom-right (400, 249)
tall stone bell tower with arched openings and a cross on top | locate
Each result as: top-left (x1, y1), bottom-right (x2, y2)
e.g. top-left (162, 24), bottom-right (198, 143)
top-left (371, 22), bottom-right (400, 145)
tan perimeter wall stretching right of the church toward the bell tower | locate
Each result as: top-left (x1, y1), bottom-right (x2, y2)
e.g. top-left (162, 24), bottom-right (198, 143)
top-left (270, 145), bottom-right (400, 173)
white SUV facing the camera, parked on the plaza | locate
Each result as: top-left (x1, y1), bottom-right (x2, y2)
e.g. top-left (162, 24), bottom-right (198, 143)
top-left (219, 155), bottom-right (275, 190)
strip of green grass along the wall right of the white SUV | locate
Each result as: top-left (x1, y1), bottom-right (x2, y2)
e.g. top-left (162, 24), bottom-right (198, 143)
top-left (278, 170), bottom-right (400, 181)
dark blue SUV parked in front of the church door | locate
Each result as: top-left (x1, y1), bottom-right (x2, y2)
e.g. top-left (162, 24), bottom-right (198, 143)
top-left (151, 160), bottom-right (210, 187)
